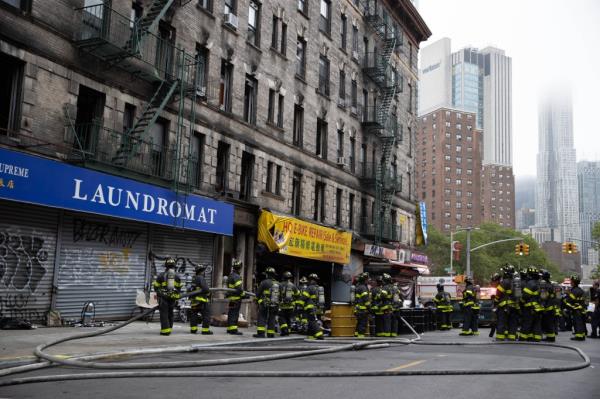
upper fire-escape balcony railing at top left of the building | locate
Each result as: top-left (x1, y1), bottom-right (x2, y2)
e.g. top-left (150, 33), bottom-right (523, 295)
top-left (74, 4), bottom-right (196, 88)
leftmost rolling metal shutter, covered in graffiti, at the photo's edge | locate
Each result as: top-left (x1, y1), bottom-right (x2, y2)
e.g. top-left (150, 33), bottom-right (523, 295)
top-left (0, 201), bottom-right (58, 322)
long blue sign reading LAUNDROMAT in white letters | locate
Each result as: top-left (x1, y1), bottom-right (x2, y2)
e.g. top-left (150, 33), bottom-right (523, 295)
top-left (0, 148), bottom-right (233, 235)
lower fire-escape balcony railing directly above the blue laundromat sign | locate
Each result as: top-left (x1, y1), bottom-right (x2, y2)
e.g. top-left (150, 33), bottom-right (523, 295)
top-left (65, 123), bottom-right (177, 180)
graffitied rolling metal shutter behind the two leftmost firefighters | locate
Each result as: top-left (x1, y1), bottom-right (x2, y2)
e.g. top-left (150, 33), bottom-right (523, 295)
top-left (151, 226), bottom-right (215, 286)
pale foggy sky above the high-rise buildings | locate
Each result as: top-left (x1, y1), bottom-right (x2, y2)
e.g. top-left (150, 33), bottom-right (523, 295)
top-left (419, 0), bottom-right (600, 175)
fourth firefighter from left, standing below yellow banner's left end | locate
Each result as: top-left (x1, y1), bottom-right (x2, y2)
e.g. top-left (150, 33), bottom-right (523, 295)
top-left (253, 267), bottom-right (279, 338)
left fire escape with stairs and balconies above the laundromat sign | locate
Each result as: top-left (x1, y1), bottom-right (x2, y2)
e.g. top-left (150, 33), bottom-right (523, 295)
top-left (67, 0), bottom-right (197, 193)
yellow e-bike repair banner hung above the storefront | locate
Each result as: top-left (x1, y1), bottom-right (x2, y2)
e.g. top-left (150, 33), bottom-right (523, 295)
top-left (258, 211), bottom-right (352, 264)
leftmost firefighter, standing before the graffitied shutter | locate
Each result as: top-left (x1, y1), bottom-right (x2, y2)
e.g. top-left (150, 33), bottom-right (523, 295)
top-left (152, 258), bottom-right (183, 335)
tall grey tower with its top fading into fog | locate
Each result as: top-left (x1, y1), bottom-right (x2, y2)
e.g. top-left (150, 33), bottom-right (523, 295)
top-left (535, 90), bottom-right (581, 241)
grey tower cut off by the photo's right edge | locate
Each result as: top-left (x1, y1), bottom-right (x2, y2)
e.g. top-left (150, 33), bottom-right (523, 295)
top-left (577, 161), bottom-right (600, 265)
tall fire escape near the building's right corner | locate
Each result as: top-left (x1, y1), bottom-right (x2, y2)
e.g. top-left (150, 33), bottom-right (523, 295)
top-left (361, 0), bottom-right (402, 243)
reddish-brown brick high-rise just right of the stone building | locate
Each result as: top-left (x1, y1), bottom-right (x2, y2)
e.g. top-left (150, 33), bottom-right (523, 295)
top-left (416, 108), bottom-right (482, 233)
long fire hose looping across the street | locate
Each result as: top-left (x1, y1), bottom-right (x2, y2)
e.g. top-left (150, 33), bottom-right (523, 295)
top-left (0, 288), bottom-right (591, 386)
